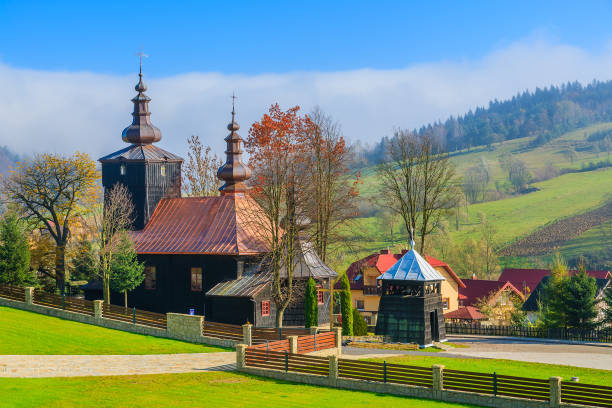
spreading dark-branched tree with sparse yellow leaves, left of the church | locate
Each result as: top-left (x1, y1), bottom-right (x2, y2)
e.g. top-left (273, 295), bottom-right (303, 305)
top-left (2, 153), bottom-right (99, 293)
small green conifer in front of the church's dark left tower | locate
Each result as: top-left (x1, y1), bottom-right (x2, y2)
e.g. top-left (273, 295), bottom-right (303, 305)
top-left (110, 232), bottom-right (145, 307)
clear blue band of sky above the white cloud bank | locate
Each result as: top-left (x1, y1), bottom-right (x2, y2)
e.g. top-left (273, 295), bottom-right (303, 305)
top-left (0, 0), bottom-right (612, 76)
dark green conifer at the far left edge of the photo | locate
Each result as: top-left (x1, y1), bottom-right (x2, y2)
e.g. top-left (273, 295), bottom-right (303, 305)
top-left (0, 212), bottom-right (33, 285)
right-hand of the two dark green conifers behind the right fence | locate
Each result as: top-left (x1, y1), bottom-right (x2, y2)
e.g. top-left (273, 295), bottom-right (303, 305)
top-left (563, 263), bottom-right (597, 330)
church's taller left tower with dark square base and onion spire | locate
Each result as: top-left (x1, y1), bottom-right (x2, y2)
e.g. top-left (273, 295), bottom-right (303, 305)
top-left (99, 64), bottom-right (183, 230)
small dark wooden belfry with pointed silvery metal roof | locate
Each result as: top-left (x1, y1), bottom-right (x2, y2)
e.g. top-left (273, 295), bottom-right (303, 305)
top-left (376, 241), bottom-right (446, 345)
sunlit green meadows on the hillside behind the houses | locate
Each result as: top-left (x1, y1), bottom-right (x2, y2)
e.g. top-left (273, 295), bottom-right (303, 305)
top-left (334, 122), bottom-right (612, 270)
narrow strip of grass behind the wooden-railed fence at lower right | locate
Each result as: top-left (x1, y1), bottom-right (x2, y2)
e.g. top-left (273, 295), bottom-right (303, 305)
top-left (372, 355), bottom-right (612, 386)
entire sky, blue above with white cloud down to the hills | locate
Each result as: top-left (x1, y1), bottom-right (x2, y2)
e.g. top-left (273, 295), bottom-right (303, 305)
top-left (0, 0), bottom-right (612, 157)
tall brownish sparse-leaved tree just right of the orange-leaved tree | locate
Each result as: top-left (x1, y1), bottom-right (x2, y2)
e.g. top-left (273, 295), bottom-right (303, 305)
top-left (305, 107), bottom-right (359, 262)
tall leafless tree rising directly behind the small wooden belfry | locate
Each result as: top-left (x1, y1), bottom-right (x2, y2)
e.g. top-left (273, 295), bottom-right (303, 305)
top-left (377, 130), bottom-right (458, 251)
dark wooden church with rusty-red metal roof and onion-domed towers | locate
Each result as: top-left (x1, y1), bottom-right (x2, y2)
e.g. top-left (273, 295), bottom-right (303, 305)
top-left (94, 70), bottom-right (337, 327)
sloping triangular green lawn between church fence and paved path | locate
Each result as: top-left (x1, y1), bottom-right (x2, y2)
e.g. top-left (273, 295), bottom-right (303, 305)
top-left (0, 306), bottom-right (227, 354)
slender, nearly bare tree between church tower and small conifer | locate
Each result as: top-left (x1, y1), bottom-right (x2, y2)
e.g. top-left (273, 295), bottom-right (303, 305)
top-left (94, 183), bottom-right (134, 304)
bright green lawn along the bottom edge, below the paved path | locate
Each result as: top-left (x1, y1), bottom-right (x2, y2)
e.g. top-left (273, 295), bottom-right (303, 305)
top-left (0, 372), bottom-right (478, 408)
